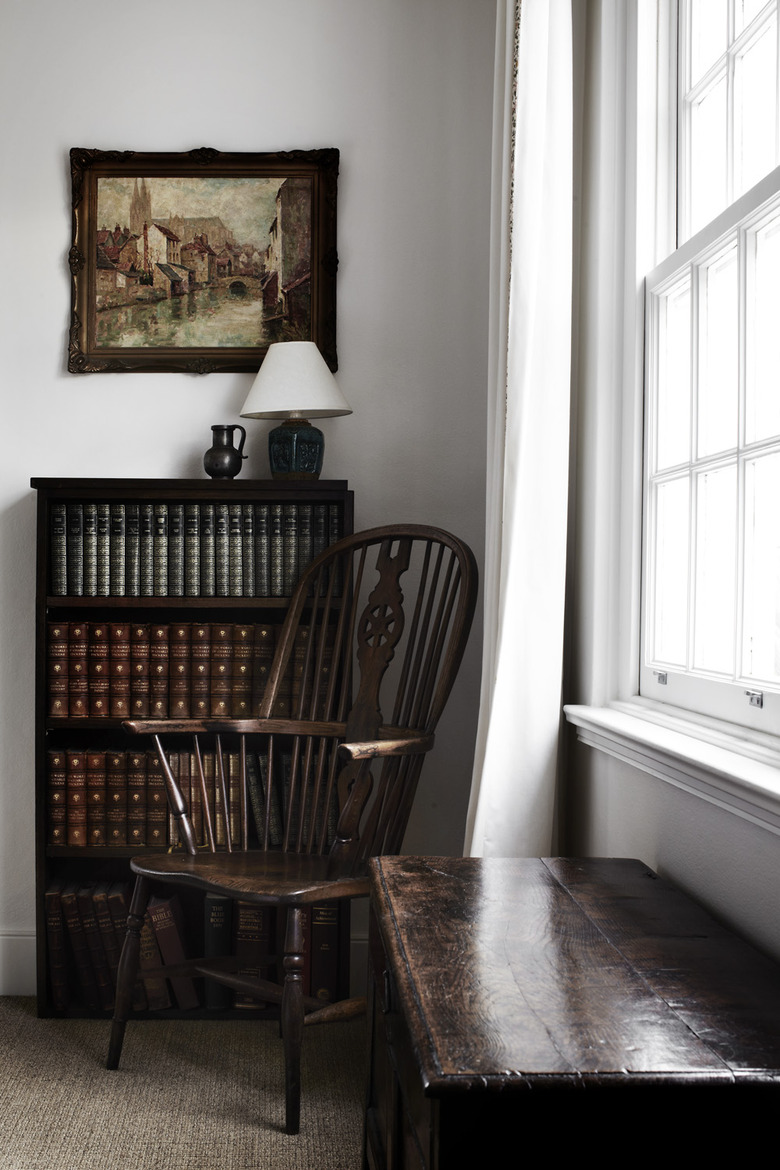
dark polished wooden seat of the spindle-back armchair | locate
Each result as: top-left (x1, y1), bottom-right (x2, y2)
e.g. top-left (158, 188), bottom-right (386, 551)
top-left (130, 852), bottom-right (368, 906)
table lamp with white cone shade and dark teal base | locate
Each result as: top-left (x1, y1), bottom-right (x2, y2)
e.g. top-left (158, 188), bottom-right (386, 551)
top-left (241, 342), bottom-right (352, 480)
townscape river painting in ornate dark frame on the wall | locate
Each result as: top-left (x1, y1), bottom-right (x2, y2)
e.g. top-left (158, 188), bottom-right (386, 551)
top-left (68, 147), bottom-right (339, 373)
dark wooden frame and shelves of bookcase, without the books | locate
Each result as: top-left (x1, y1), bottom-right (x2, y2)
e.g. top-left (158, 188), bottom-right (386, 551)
top-left (30, 477), bottom-right (354, 1019)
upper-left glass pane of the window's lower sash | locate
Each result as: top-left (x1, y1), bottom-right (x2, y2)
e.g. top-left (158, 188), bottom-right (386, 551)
top-left (656, 278), bottom-right (691, 468)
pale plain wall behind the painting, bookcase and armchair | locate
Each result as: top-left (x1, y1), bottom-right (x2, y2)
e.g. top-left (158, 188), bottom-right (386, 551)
top-left (0, 0), bottom-right (495, 993)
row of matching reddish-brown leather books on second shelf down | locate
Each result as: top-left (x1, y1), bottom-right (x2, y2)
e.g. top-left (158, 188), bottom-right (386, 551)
top-left (47, 621), bottom-right (315, 720)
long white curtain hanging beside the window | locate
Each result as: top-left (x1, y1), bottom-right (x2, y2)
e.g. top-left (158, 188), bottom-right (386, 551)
top-left (464, 0), bottom-right (573, 856)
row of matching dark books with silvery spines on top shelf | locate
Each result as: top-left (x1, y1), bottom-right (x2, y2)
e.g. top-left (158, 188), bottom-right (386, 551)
top-left (49, 501), bottom-right (344, 598)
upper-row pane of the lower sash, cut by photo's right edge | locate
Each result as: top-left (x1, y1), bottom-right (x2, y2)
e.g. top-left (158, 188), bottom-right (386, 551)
top-left (745, 218), bottom-right (780, 442)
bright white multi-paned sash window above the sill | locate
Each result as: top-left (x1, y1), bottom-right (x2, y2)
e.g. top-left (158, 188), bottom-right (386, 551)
top-left (640, 0), bottom-right (780, 734)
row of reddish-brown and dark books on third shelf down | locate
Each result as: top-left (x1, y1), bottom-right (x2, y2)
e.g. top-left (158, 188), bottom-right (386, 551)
top-left (47, 748), bottom-right (301, 848)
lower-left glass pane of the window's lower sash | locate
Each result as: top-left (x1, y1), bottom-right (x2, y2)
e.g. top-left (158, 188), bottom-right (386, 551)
top-left (650, 479), bottom-right (689, 666)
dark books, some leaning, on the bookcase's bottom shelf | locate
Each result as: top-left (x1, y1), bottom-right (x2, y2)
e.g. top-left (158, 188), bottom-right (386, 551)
top-left (44, 880), bottom-right (341, 1012)
